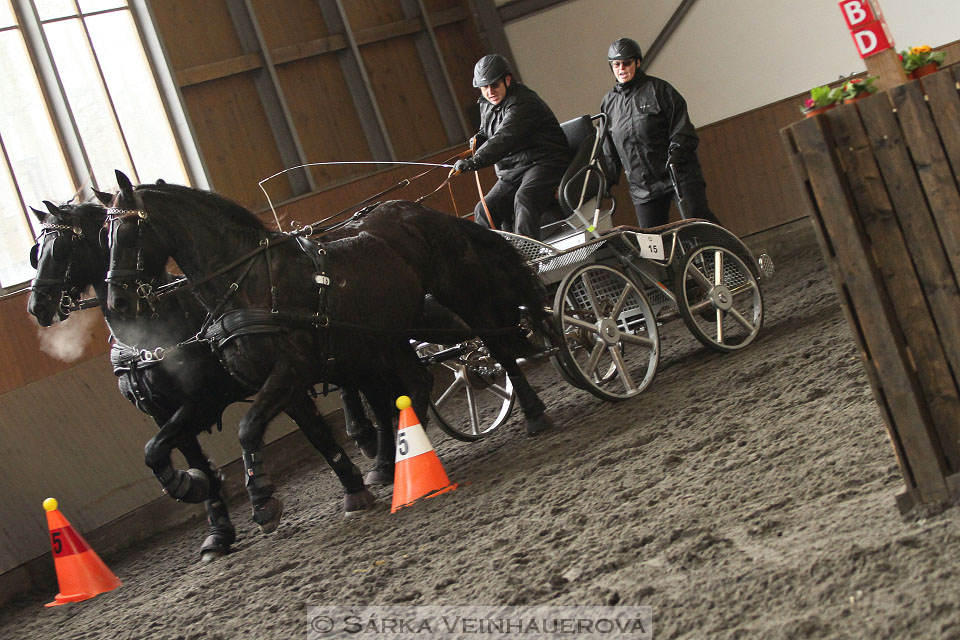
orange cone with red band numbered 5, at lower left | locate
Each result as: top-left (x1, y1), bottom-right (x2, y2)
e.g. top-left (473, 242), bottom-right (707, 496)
top-left (43, 498), bottom-right (123, 607)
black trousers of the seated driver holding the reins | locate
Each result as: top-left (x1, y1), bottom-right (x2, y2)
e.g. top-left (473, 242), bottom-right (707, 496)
top-left (473, 165), bottom-right (564, 240)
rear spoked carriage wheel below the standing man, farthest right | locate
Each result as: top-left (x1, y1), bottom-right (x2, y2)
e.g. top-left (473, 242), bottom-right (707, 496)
top-left (673, 246), bottom-right (763, 353)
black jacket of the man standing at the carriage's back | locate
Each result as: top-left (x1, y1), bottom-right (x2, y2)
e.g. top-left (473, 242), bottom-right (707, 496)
top-left (600, 69), bottom-right (704, 202)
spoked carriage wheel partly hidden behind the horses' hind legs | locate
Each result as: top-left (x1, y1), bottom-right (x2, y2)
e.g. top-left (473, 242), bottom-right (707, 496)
top-left (417, 341), bottom-right (516, 442)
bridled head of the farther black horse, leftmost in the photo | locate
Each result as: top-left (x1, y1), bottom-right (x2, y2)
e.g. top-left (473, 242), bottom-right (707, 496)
top-left (27, 201), bottom-right (108, 327)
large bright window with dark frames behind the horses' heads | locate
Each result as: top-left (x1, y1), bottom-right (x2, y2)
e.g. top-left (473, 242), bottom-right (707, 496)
top-left (0, 0), bottom-right (190, 288)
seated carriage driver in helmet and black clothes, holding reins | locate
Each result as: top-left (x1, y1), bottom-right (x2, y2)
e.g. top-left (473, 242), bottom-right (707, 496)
top-left (453, 54), bottom-right (570, 240)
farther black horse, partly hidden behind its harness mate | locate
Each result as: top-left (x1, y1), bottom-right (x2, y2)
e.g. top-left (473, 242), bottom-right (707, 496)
top-left (28, 199), bottom-right (376, 562)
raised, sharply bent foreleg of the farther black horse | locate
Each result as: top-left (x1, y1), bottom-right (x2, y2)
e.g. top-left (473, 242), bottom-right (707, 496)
top-left (143, 405), bottom-right (210, 504)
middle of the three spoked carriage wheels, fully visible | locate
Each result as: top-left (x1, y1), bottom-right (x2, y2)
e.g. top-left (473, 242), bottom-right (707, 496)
top-left (553, 264), bottom-right (660, 400)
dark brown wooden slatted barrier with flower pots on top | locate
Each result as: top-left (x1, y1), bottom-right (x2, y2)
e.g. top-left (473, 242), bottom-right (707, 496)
top-left (781, 65), bottom-right (960, 514)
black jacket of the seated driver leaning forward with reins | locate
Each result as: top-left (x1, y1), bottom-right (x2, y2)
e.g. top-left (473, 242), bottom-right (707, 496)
top-left (475, 80), bottom-right (570, 181)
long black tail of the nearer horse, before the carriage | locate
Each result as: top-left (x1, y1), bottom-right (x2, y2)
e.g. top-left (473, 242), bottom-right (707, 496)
top-left (458, 220), bottom-right (563, 355)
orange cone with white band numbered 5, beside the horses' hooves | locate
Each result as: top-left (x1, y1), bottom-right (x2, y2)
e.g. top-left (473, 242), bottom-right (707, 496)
top-left (390, 396), bottom-right (457, 513)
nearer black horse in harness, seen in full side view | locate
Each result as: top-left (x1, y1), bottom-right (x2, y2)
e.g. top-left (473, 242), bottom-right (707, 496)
top-left (108, 171), bottom-right (560, 536)
